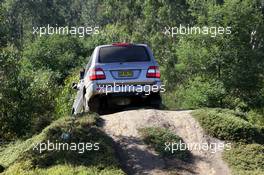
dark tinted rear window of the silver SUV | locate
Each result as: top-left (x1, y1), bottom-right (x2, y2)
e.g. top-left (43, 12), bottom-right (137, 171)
top-left (99, 46), bottom-right (150, 63)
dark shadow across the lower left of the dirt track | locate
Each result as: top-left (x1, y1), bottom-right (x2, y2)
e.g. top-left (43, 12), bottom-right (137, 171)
top-left (109, 136), bottom-right (196, 175)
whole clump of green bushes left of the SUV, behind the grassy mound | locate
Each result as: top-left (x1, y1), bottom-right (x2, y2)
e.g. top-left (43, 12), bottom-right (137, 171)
top-left (0, 36), bottom-right (86, 139)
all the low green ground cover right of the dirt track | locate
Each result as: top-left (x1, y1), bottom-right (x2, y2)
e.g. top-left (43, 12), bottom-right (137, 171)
top-left (192, 109), bottom-right (264, 175)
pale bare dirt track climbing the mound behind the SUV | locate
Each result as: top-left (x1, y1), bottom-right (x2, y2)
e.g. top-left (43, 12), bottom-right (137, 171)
top-left (101, 109), bottom-right (230, 175)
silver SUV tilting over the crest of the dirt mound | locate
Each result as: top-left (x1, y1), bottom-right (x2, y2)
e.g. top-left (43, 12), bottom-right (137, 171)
top-left (72, 43), bottom-right (163, 114)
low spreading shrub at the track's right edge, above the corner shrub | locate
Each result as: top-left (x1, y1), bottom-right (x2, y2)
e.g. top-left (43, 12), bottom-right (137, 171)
top-left (192, 109), bottom-right (264, 144)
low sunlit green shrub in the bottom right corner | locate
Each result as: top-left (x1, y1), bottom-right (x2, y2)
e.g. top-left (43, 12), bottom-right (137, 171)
top-left (223, 144), bottom-right (264, 175)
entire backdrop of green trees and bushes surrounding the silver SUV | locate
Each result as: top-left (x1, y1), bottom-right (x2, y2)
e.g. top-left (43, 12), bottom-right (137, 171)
top-left (0, 0), bottom-right (264, 142)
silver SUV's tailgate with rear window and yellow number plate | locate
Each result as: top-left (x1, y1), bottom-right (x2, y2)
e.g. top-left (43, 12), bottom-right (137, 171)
top-left (97, 44), bottom-right (154, 82)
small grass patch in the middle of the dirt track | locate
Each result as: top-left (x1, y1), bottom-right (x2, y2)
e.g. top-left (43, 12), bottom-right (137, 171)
top-left (139, 127), bottom-right (191, 161)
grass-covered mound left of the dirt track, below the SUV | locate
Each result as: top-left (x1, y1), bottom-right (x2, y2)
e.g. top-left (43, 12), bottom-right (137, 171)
top-left (0, 114), bottom-right (125, 175)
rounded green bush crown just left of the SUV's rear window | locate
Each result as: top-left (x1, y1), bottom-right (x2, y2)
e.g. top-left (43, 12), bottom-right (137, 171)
top-left (23, 35), bottom-right (88, 83)
